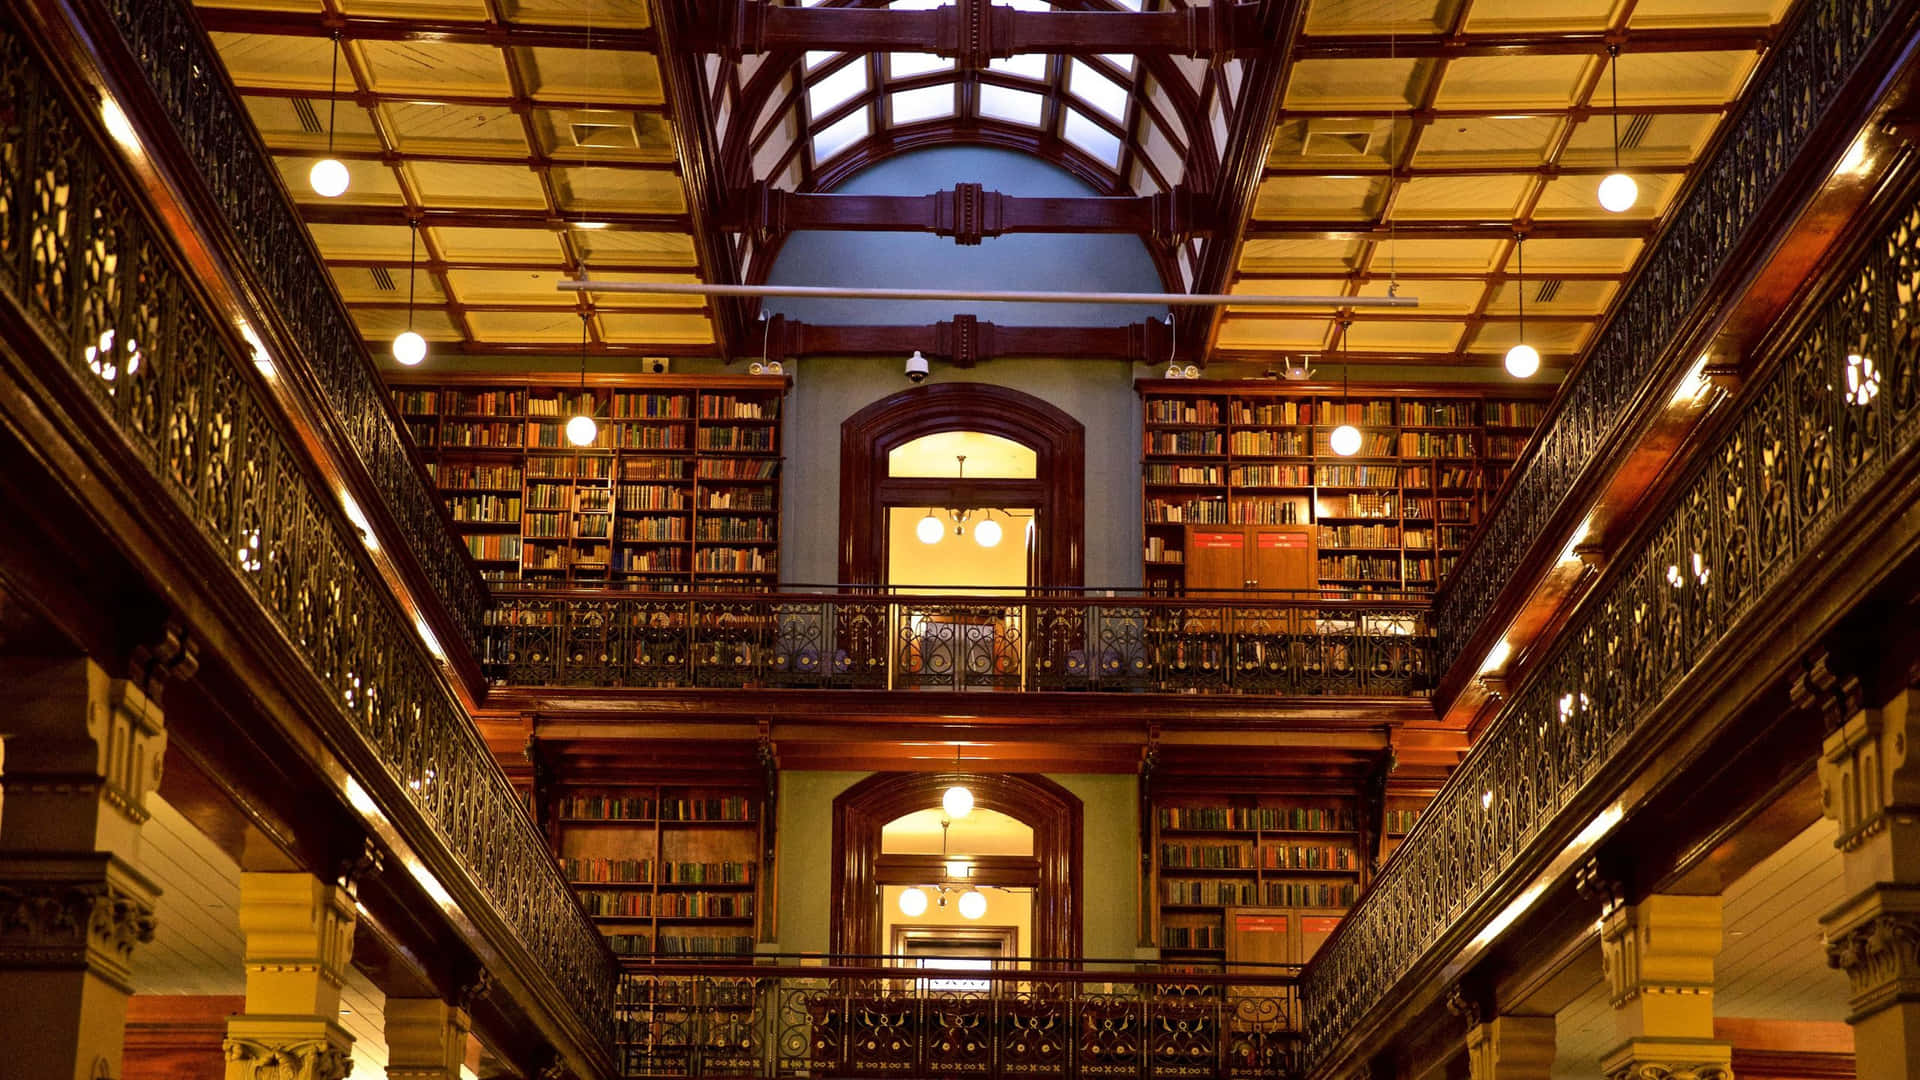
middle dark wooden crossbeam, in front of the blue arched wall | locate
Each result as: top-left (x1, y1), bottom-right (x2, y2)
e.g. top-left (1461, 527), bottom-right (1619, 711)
top-left (720, 183), bottom-right (1212, 244)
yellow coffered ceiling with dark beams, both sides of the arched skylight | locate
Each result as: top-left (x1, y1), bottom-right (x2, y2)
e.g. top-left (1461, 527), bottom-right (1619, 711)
top-left (187, 0), bottom-right (1791, 367)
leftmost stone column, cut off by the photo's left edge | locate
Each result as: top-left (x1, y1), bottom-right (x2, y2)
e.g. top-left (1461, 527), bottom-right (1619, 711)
top-left (0, 657), bottom-right (167, 1080)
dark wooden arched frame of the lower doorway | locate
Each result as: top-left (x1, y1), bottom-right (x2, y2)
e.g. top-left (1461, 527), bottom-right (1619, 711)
top-left (831, 773), bottom-right (1081, 957)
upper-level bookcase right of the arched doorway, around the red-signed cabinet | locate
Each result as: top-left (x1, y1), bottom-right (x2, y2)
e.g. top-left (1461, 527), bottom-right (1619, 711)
top-left (1135, 379), bottom-right (1549, 594)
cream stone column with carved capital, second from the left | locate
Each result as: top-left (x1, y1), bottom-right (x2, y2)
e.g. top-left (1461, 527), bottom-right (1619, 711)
top-left (223, 872), bottom-right (353, 1080)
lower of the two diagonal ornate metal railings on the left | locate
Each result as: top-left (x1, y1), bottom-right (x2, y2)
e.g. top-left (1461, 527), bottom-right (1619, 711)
top-left (0, 16), bottom-right (614, 1034)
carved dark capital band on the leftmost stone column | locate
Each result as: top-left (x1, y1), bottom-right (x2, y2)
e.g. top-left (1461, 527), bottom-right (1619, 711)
top-left (0, 853), bottom-right (159, 994)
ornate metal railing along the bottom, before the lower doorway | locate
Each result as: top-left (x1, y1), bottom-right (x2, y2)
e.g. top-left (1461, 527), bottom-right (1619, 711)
top-left (616, 969), bottom-right (1300, 1080)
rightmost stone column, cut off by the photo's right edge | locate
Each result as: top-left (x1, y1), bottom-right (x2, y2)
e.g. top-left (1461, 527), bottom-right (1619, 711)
top-left (1820, 688), bottom-right (1920, 1080)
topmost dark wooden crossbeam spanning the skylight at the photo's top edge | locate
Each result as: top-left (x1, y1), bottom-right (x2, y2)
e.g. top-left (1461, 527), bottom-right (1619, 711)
top-left (695, 0), bottom-right (1273, 69)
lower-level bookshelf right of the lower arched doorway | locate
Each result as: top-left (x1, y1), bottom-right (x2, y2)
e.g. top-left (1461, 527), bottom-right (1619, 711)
top-left (1150, 792), bottom-right (1365, 963)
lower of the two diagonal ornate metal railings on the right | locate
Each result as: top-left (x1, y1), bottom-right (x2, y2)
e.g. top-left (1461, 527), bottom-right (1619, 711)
top-left (1302, 176), bottom-right (1920, 1057)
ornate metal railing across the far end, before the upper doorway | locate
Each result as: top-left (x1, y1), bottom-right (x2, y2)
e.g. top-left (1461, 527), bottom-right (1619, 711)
top-left (482, 592), bottom-right (1434, 698)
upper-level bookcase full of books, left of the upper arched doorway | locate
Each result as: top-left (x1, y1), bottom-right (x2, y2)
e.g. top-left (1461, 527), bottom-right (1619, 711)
top-left (390, 373), bottom-right (789, 592)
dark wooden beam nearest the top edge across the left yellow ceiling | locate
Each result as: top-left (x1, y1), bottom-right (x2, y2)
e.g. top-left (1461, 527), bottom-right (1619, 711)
top-left (194, 6), bottom-right (660, 52)
